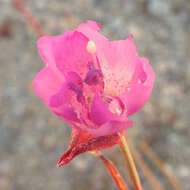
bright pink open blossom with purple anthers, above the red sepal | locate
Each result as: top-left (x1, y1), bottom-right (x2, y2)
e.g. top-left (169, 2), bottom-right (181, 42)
top-left (34, 21), bottom-right (154, 166)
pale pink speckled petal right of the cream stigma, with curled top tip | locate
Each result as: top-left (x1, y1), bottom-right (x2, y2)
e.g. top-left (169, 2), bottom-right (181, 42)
top-left (77, 21), bottom-right (139, 96)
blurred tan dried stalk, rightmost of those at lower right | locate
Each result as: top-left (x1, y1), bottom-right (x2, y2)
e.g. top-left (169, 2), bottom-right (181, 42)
top-left (139, 141), bottom-right (184, 190)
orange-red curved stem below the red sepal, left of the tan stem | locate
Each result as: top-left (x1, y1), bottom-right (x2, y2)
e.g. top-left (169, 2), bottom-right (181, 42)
top-left (90, 151), bottom-right (128, 190)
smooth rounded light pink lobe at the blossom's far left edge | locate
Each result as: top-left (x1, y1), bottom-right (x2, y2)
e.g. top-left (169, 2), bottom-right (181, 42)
top-left (33, 66), bottom-right (62, 104)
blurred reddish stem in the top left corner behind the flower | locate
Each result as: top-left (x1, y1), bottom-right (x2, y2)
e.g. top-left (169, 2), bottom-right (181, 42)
top-left (12, 0), bottom-right (47, 36)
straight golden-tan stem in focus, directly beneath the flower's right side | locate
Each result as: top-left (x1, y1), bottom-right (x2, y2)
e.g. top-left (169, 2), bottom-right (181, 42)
top-left (119, 135), bottom-right (142, 190)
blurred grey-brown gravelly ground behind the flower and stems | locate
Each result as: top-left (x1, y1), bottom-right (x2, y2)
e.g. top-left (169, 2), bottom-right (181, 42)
top-left (0, 0), bottom-right (190, 190)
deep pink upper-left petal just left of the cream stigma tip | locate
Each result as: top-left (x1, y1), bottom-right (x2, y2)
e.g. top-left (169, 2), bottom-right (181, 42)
top-left (53, 31), bottom-right (93, 78)
